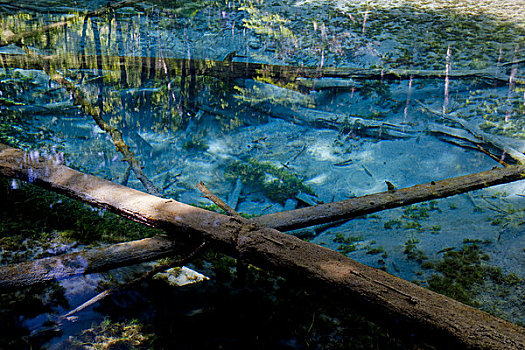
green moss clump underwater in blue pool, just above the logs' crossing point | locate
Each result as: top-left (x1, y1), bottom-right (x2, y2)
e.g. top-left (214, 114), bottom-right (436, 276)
top-left (225, 158), bottom-right (315, 204)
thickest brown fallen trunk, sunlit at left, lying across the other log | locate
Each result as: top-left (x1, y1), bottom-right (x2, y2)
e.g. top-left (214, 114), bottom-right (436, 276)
top-left (0, 145), bottom-right (525, 349)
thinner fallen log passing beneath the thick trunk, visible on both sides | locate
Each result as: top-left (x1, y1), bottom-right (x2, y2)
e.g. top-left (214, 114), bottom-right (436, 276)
top-left (4, 162), bottom-right (525, 289)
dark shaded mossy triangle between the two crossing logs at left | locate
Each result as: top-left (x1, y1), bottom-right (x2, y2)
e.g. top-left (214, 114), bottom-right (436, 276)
top-left (0, 178), bottom-right (159, 263)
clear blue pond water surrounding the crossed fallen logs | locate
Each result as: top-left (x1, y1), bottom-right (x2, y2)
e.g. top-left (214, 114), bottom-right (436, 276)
top-left (0, 0), bottom-right (525, 348)
